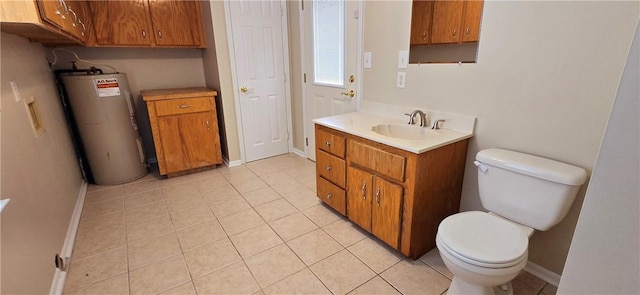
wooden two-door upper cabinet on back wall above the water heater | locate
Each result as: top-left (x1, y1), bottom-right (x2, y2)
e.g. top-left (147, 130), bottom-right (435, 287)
top-left (89, 0), bottom-right (205, 48)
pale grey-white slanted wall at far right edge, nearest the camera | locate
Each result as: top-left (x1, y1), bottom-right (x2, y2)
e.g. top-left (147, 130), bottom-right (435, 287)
top-left (558, 20), bottom-right (640, 294)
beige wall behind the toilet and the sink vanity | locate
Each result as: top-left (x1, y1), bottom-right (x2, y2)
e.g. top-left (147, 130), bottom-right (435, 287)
top-left (363, 1), bottom-right (639, 274)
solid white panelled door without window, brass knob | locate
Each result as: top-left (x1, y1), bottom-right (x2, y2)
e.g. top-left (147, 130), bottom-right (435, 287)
top-left (228, 1), bottom-right (289, 162)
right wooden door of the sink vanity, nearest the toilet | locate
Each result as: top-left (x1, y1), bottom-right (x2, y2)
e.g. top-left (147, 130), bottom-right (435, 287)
top-left (371, 177), bottom-right (404, 249)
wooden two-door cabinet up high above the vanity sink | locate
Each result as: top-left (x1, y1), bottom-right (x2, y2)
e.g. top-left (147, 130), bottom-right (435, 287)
top-left (410, 0), bottom-right (484, 45)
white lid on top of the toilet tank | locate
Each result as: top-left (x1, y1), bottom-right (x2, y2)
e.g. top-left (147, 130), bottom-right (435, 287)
top-left (476, 148), bottom-right (587, 185)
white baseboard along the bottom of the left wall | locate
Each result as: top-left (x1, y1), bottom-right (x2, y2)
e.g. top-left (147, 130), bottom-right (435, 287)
top-left (49, 181), bottom-right (87, 295)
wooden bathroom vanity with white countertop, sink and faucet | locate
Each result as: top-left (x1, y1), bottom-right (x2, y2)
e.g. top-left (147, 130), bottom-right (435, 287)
top-left (314, 112), bottom-right (475, 259)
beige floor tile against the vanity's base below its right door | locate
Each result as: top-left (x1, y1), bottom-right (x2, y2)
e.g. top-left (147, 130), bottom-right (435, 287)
top-left (347, 237), bottom-right (402, 273)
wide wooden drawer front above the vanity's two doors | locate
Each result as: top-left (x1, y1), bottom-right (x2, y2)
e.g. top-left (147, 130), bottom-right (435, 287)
top-left (348, 140), bottom-right (406, 182)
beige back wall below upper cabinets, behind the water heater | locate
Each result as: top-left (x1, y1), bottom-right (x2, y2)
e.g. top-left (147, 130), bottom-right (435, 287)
top-left (46, 47), bottom-right (205, 163)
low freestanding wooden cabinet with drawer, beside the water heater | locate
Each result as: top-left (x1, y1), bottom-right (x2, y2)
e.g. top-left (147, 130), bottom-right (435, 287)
top-left (140, 88), bottom-right (222, 175)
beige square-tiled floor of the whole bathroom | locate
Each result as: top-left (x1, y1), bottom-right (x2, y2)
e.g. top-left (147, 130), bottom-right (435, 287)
top-left (64, 154), bottom-right (555, 295)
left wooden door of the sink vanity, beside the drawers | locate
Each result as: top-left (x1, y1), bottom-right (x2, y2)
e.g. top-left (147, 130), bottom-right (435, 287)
top-left (347, 167), bottom-right (373, 232)
